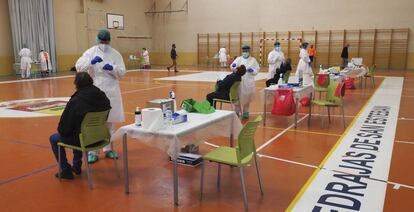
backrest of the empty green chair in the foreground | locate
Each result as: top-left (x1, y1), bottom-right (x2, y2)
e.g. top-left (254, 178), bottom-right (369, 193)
top-left (236, 116), bottom-right (262, 164)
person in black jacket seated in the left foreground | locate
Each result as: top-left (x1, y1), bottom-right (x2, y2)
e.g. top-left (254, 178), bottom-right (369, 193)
top-left (49, 72), bottom-right (111, 179)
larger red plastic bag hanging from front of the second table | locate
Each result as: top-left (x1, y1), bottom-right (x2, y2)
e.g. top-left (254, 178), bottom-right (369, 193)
top-left (272, 89), bottom-right (296, 116)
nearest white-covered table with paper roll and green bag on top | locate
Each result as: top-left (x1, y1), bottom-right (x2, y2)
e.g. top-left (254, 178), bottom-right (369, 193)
top-left (111, 110), bottom-right (242, 205)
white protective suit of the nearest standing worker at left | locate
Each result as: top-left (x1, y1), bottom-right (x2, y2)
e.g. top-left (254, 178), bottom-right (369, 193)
top-left (76, 45), bottom-right (126, 123)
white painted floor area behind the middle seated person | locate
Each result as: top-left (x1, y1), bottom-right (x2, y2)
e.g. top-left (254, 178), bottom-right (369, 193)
top-left (155, 71), bottom-right (268, 82)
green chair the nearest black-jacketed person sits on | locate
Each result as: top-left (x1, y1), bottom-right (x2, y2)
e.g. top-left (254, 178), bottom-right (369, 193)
top-left (58, 110), bottom-right (119, 189)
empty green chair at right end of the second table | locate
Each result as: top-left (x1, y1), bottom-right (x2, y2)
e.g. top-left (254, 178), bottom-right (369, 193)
top-left (308, 81), bottom-right (345, 128)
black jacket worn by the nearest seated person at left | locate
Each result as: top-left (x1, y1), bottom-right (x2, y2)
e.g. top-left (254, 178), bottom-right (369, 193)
top-left (58, 85), bottom-right (111, 146)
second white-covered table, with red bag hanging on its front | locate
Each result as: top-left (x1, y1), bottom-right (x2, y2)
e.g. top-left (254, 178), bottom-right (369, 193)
top-left (262, 85), bottom-right (313, 128)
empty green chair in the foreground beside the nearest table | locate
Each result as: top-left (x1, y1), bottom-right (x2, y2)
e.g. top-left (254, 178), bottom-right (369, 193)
top-left (200, 116), bottom-right (263, 210)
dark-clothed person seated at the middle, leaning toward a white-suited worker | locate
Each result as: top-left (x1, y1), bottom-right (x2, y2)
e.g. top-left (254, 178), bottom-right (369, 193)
top-left (206, 65), bottom-right (246, 107)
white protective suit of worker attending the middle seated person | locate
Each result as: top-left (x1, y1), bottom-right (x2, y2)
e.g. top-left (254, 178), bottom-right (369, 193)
top-left (230, 56), bottom-right (260, 112)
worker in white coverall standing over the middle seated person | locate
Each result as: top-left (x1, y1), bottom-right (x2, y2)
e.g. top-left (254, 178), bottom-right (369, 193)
top-left (230, 46), bottom-right (260, 119)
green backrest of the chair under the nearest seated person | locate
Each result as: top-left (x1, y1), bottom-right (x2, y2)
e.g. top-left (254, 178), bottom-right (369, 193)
top-left (79, 110), bottom-right (111, 148)
